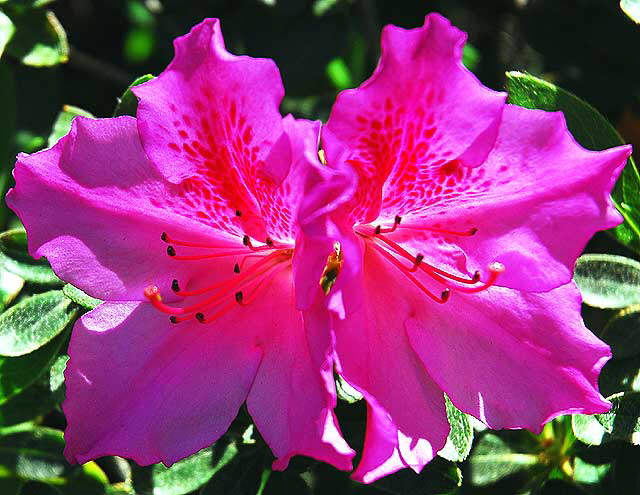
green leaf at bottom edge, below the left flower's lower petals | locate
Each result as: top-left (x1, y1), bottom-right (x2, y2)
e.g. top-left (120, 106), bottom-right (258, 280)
top-left (133, 442), bottom-right (238, 495)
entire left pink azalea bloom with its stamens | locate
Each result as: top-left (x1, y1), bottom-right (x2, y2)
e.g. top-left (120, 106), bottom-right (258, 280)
top-left (7, 20), bottom-right (354, 469)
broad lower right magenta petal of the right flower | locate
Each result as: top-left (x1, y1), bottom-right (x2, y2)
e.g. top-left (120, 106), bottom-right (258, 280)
top-left (405, 284), bottom-right (611, 432)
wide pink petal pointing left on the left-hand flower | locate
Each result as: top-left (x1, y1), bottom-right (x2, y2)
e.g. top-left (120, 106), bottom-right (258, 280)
top-left (7, 116), bottom-right (243, 300)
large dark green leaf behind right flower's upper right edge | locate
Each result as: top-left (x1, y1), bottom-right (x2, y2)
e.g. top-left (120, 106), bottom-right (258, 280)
top-left (507, 72), bottom-right (640, 252)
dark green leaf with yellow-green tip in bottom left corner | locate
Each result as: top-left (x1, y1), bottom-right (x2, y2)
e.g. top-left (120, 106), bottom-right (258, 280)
top-left (0, 427), bottom-right (108, 495)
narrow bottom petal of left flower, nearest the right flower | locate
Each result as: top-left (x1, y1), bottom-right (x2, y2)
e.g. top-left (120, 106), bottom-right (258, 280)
top-left (247, 272), bottom-right (355, 470)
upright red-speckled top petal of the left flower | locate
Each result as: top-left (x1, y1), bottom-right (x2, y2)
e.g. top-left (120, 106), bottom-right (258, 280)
top-left (133, 19), bottom-right (288, 239)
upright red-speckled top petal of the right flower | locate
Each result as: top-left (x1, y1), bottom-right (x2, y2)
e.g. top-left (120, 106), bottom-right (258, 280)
top-left (323, 14), bottom-right (505, 222)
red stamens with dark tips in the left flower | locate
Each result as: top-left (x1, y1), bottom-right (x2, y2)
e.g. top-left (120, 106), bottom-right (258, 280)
top-left (144, 227), bottom-right (293, 323)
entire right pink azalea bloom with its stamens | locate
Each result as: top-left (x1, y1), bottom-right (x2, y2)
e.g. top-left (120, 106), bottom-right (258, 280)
top-left (314, 14), bottom-right (630, 482)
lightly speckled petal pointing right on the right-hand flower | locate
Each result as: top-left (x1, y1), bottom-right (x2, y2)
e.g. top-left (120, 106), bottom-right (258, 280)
top-left (392, 105), bottom-right (631, 292)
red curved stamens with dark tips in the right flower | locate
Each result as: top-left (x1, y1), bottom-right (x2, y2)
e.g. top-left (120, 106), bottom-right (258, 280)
top-left (354, 216), bottom-right (505, 304)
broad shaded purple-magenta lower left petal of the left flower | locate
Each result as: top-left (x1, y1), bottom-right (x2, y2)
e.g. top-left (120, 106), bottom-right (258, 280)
top-left (63, 303), bottom-right (262, 465)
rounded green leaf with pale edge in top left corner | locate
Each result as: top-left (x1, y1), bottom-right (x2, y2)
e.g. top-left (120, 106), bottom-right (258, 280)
top-left (6, 10), bottom-right (69, 67)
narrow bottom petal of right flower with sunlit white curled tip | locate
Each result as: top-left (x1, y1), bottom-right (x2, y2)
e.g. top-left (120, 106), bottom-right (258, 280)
top-left (329, 240), bottom-right (449, 477)
